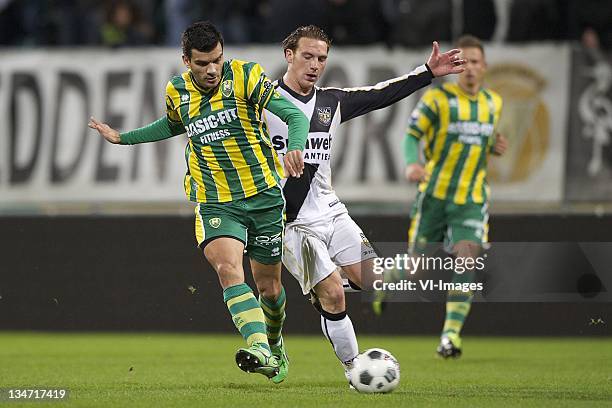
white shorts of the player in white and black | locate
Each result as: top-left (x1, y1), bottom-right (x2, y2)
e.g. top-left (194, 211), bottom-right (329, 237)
top-left (283, 213), bottom-right (377, 294)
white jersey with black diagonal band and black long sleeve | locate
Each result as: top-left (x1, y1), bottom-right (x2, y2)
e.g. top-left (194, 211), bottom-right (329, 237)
top-left (265, 64), bottom-right (433, 224)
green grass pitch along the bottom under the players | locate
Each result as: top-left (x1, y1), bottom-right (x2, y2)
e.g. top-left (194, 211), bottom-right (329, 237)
top-left (0, 332), bottom-right (612, 408)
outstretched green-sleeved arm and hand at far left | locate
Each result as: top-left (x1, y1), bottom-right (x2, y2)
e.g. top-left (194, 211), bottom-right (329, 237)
top-left (87, 116), bottom-right (185, 145)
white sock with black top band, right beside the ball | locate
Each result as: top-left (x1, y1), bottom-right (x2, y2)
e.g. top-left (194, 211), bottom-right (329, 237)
top-left (321, 312), bottom-right (359, 364)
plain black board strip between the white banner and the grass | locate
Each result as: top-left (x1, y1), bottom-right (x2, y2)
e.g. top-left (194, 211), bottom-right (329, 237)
top-left (0, 215), bottom-right (612, 335)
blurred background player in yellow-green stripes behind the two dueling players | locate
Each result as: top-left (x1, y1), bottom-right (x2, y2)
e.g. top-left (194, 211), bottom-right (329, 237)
top-left (375, 35), bottom-right (508, 358)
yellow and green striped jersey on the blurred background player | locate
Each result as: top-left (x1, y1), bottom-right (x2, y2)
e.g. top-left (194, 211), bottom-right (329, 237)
top-left (407, 83), bottom-right (502, 204)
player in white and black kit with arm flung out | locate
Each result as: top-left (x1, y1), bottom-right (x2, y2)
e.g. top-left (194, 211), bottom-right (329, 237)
top-left (266, 26), bottom-right (465, 380)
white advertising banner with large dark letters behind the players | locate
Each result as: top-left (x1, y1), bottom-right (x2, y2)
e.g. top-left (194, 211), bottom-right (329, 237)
top-left (0, 45), bottom-right (570, 206)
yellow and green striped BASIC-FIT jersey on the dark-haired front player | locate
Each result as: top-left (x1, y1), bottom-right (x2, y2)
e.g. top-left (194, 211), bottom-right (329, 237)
top-left (166, 60), bottom-right (283, 203)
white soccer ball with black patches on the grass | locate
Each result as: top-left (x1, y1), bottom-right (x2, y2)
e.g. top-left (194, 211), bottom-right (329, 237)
top-left (350, 348), bottom-right (399, 393)
